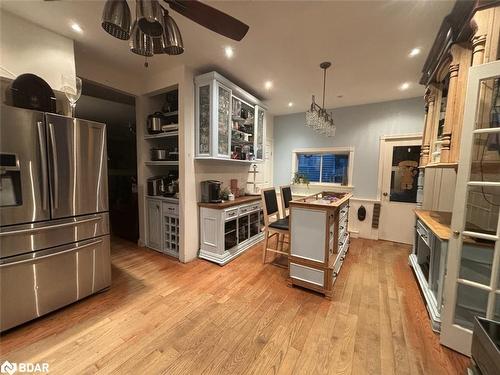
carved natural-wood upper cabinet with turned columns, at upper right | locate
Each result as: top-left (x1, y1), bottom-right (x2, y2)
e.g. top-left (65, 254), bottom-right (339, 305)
top-left (420, 1), bottom-right (500, 168)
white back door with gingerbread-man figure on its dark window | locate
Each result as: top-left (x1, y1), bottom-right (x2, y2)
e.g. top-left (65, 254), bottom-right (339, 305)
top-left (378, 134), bottom-right (422, 244)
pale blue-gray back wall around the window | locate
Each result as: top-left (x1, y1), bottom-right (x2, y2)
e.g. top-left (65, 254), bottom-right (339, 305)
top-left (273, 98), bottom-right (424, 199)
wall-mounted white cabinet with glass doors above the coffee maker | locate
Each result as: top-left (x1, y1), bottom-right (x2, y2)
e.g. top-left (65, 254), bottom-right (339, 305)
top-left (195, 72), bottom-right (265, 163)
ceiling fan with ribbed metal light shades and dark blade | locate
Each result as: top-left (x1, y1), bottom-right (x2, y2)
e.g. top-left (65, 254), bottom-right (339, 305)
top-left (101, 0), bottom-right (249, 67)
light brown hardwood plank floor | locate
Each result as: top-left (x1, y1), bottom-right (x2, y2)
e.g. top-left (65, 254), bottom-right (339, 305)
top-left (0, 239), bottom-right (468, 375)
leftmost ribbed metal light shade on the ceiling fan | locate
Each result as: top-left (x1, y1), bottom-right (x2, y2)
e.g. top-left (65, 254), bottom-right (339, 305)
top-left (101, 0), bottom-right (131, 40)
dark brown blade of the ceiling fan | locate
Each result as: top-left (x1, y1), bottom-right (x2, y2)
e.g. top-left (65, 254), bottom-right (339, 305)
top-left (164, 0), bottom-right (249, 41)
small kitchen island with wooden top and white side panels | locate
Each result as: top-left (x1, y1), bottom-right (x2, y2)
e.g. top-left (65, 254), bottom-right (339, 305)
top-left (288, 191), bottom-right (352, 298)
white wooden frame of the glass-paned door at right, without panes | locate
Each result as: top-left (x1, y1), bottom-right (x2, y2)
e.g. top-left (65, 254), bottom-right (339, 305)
top-left (440, 61), bottom-right (500, 355)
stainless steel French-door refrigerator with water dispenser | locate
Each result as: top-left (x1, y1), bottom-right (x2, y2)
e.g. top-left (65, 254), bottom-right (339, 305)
top-left (0, 105), bottom-right (111, 331)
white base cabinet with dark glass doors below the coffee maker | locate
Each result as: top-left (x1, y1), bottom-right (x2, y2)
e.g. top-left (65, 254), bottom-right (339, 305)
top-left (200, 200), bottom-right (263, 266)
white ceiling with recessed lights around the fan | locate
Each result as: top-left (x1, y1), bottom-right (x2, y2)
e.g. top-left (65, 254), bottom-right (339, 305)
top-left (1, 0), bottom-right (454, 114)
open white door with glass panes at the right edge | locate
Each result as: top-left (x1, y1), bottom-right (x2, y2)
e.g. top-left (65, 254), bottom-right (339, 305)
top-left (441, 61), bottom-right (500, 355)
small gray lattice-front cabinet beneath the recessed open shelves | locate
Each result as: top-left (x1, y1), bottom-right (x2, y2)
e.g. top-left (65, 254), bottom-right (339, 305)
top-left (146, 197), bottom-right (180, 258)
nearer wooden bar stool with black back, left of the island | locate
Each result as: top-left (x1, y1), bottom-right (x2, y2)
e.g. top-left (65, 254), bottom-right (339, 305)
top-left (261, 187), bottom-right (290, 264)
